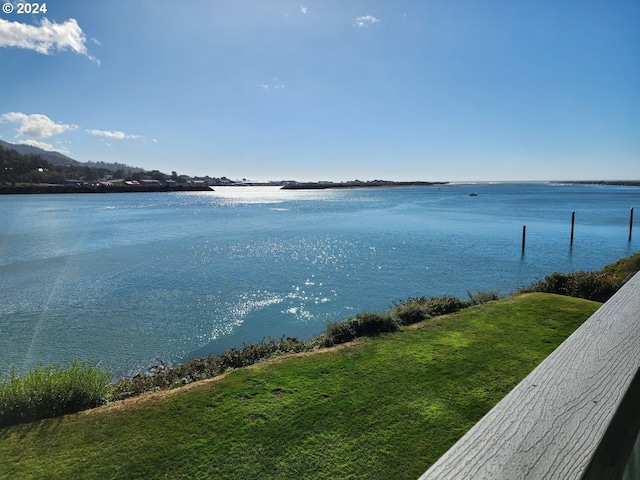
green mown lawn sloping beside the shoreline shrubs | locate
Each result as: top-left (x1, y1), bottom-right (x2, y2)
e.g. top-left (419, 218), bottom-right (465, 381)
top-left (0, 293), bottom-right (599, 479)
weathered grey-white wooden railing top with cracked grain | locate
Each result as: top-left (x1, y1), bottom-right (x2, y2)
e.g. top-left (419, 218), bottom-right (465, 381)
top-left (420, 273), bottom-right (640, 480)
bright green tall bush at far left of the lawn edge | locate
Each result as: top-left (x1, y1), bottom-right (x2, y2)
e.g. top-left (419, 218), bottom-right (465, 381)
top-left (0, 360), bottom-right (111, 426)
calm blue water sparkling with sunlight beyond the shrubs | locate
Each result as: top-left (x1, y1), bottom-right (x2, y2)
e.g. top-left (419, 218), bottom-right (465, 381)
top-left (0, 184), bottom-right (640, 375)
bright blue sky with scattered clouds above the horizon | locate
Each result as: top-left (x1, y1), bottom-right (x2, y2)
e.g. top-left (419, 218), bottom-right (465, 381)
top-left (0, 0), bottom-right (640, 181)
